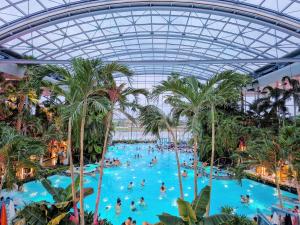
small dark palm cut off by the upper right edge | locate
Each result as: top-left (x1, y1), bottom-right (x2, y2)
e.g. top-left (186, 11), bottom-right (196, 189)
top-left (282, 76), bottom-right (300, 117)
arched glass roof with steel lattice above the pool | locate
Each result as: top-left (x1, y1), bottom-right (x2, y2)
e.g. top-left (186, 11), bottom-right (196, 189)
top-left (0, 0), bottom-right (300, 79)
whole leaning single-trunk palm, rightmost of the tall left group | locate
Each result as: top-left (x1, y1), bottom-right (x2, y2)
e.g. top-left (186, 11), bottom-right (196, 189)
top-left (94, 63), bottom-right (148, 224)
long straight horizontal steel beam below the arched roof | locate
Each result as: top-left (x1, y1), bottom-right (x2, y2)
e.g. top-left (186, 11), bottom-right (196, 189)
top-left (0, 58), bottom-right (300, 65)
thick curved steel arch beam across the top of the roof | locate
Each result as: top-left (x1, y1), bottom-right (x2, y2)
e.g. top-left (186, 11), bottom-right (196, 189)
top-left (0, 0), bottom-right (300, 44)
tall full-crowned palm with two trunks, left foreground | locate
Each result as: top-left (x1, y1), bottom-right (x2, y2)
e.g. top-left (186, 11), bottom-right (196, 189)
top-left (41, 58), bottom-right (107, 225)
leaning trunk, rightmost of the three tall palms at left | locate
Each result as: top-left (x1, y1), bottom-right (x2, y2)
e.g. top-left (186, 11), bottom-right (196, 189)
top-left (94, 110), bottom-right (113, 224)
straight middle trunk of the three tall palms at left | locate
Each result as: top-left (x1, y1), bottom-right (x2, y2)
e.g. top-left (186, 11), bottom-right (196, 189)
top-left (79, 97), bottom-right (87, 225)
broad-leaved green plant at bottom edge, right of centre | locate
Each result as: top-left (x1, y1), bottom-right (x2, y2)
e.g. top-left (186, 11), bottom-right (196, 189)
top-left (158, 186), bottom-right (233, 225)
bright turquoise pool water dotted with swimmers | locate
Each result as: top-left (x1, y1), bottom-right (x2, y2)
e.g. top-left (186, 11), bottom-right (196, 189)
top-left (9, 144), bottom-right (296, 225)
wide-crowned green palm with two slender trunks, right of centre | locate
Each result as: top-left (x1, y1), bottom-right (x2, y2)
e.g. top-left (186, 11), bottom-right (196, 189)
top-left (154, 71), bottom-right (249, 215)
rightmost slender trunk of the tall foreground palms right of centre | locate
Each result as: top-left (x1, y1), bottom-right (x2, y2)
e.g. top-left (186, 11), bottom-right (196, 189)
top-left (206, 104), bottom-right (215, 216)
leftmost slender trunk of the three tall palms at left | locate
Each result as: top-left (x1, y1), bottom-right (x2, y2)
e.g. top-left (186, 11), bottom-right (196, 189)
top-left (68, 117), bottom-right (79, 223)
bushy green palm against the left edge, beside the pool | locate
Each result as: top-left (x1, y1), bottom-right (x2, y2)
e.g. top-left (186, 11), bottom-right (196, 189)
top-left (0, 124), bottom-right (46, 192)
